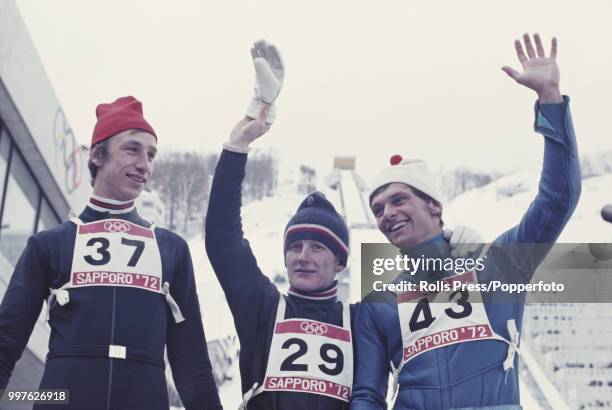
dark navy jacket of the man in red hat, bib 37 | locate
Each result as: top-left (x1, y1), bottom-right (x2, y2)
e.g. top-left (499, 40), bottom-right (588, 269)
top-left (0, 207), bottom-right (222, 410)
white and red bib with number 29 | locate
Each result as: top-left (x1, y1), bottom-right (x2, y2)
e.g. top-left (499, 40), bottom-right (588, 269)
top-left (240, 295), bottom-right (353, 409)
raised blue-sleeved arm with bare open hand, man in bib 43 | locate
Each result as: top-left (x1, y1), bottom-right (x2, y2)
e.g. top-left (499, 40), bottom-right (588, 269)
top-left (495, 34), bottom-right (581, 280)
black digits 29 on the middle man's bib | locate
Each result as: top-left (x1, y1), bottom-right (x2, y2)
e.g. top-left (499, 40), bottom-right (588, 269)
top-left (281, 337), bottom-right (344, 376)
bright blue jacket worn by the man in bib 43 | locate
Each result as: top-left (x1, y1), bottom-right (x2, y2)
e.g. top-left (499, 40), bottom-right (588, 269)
top-left (350, 97), bottom-right (581, 410)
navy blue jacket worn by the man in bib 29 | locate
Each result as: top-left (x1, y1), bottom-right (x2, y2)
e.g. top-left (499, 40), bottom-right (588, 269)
top-left (206, 150), bottom-right (354, 410)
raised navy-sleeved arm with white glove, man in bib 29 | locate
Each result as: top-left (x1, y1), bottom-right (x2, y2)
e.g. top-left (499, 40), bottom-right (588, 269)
top-left (205, 41), bottom-right (282, 340)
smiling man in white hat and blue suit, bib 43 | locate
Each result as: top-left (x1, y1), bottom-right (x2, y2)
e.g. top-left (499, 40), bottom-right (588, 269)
top-left (351, 34), bottom-right (581, 410)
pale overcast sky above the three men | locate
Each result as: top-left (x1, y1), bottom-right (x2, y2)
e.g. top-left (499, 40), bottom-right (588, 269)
top-left (17, 0), bottom-right (612, 180)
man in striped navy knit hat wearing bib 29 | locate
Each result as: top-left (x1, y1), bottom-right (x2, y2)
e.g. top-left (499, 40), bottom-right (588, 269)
top-left (206, 40), bottom-right (354, 410)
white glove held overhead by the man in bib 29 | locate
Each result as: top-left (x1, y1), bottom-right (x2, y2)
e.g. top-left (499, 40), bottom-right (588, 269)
top-left (246, 40), bottom-right (285, 124)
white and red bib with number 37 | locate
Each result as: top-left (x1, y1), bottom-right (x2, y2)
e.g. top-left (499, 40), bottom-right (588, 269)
top-left (70, 219), bottom-right (163, 293)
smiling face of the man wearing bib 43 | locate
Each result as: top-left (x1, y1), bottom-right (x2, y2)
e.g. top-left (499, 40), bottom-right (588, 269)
top-left (370, 182), bottom-right (442, 249)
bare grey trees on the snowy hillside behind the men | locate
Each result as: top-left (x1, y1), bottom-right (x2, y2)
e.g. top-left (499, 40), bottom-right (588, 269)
top-left (150, 151), bottom-right (612, 238)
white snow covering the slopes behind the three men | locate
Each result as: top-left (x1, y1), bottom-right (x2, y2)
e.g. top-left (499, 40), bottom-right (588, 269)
top-left (189, 173), bottom-right (612, 410)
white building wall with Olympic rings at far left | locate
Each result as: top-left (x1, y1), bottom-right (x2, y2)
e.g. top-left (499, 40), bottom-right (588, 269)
top-left (0, 0), bottom-right (90, 211)
